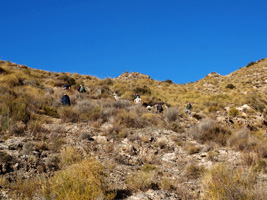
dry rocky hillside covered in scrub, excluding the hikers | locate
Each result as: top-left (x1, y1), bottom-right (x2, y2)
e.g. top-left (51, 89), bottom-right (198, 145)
top-left (0, 59), bottom-right (267, 200)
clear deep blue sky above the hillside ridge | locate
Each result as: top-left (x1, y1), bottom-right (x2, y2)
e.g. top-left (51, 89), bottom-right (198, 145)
top-left (0, 0), bottom-right (267, 83)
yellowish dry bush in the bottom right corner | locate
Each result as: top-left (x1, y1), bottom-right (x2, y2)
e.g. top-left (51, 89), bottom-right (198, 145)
top-left (203, 165), bottom-right (267, 200)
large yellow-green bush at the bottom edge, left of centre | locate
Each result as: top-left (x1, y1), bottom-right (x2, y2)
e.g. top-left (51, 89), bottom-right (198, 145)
top-left (43, 159), bottom-right (116, 200)
